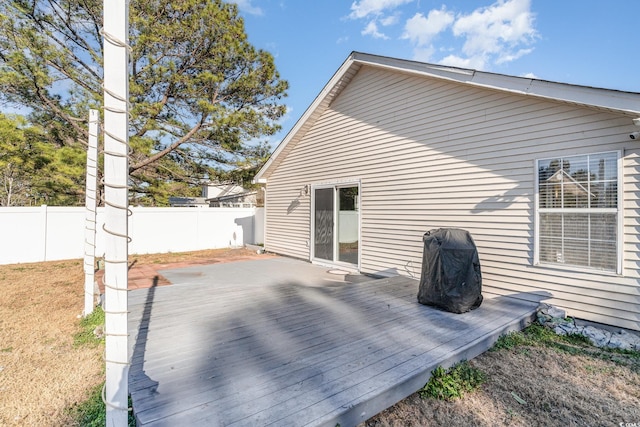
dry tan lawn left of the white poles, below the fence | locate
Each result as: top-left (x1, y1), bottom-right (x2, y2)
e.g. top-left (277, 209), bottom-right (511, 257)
top-left (0, 260), bottom-right (102, 426)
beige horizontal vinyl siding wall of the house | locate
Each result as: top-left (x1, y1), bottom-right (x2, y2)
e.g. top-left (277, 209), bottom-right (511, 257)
top-left (265, 66), bottom-right (640, 330)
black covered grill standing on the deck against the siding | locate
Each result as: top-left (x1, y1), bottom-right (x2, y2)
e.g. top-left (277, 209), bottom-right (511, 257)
top-left (418, 228), bottom-right (482, 313)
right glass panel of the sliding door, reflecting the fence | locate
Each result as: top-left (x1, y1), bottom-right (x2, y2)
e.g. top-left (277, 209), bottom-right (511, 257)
top-left (337, 187), bottom-right (360, 265)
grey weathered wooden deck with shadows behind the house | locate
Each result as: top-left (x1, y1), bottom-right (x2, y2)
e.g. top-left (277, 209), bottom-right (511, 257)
top-left (129, 258), bottom-right (535, 427)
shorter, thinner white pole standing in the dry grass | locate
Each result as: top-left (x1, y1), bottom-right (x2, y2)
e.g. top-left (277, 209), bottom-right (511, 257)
top-left (83, 110), bottom-right (99, 316)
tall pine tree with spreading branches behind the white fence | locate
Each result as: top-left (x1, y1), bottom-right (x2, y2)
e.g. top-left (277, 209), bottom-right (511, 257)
top-left (0, 0), bottom-right (288, 203)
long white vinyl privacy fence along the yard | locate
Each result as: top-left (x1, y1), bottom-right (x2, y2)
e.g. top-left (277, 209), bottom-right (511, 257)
top-left (0, 206), bottom-right (264, 265)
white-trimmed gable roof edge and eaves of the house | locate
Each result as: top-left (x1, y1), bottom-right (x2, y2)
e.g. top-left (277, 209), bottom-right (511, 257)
top-left (253, 52), bottom-right (640, 183)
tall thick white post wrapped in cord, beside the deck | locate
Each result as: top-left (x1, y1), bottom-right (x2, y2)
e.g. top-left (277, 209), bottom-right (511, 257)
top-left (103, 0), bottom-right (129, 426)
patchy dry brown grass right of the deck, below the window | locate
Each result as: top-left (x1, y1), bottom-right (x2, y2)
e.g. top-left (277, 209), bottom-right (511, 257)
top-left (365, 326), bottom-right (640, 427)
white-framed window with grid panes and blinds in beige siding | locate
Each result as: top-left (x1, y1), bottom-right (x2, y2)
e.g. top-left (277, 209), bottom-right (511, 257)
top-left (534, 151), bottom-right (622, 274)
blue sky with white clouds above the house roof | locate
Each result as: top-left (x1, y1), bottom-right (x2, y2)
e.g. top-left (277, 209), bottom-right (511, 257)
top-left (236, 0), bottom-right (640, 148)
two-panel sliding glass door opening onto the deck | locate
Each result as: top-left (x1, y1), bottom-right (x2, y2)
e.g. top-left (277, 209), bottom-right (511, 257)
top-left (312, 184), bottom-right (360, 266)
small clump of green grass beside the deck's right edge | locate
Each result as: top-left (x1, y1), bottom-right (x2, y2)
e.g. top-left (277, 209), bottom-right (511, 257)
top-left (420, 361), bottom-right (487, 400)
